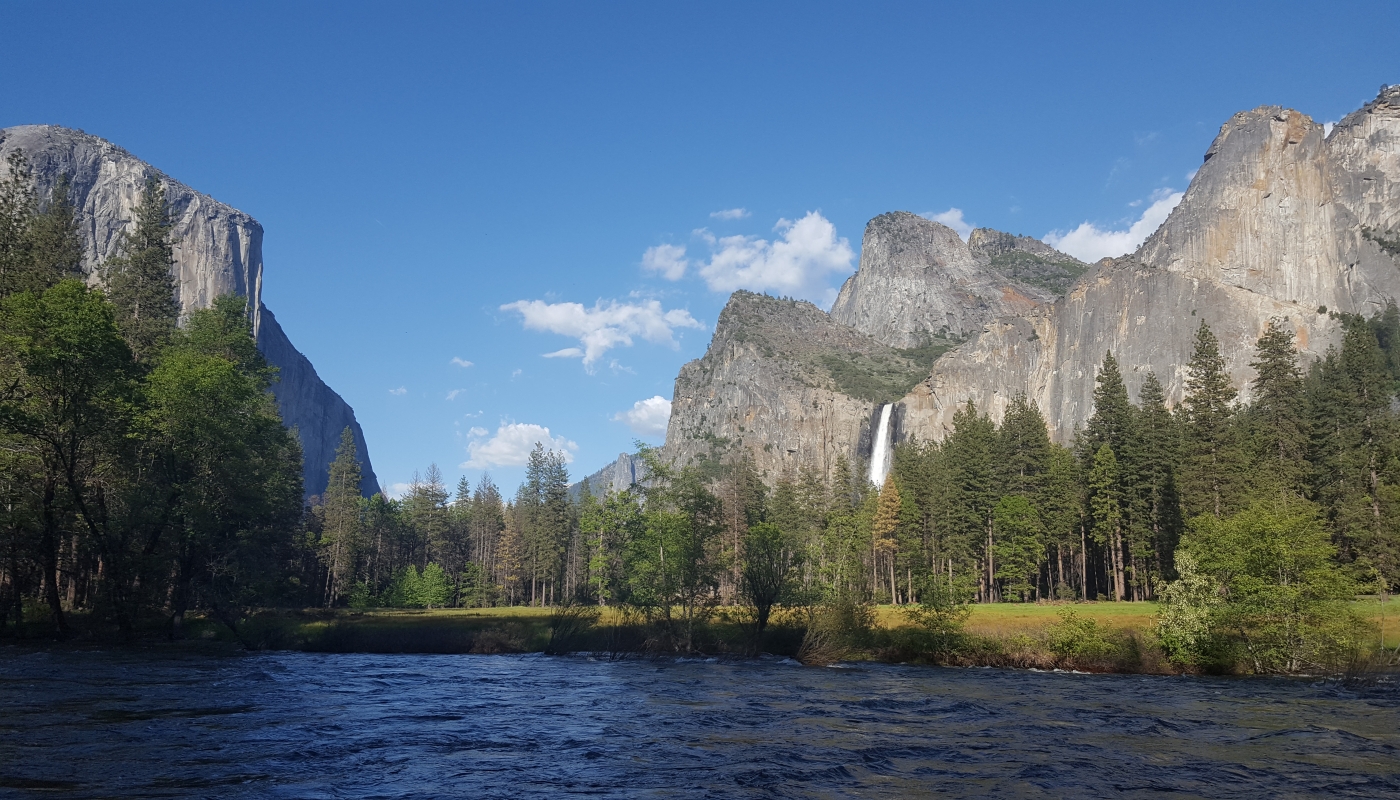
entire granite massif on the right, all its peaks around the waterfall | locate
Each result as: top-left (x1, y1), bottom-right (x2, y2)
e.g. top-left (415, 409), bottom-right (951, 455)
top-left (641, 87), bottom-right (1400, 478)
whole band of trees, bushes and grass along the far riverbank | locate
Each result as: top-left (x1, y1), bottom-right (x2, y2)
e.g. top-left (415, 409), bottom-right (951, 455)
top-left (0, 152), bottom-right (1400, 674)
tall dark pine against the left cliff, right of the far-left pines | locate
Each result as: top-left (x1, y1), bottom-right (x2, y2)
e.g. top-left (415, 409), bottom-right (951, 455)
top-left (104, 177), bottom-right (179, 361)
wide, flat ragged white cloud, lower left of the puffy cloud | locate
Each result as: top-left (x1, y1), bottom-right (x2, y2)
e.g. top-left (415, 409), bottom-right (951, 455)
top-left (501, 300), bottom-right (704, 371)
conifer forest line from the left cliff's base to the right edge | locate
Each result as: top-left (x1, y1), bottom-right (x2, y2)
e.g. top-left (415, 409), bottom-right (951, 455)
top-left (321, 305), bottom-right (1400, 624)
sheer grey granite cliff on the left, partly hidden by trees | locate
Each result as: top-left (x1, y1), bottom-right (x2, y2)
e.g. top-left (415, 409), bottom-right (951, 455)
top-left (0, 125), bottom-right (379, 495)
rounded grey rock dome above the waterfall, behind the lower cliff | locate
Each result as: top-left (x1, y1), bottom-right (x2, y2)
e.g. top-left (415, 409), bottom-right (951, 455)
top-left (832, 212), bottom-right (1052, 347)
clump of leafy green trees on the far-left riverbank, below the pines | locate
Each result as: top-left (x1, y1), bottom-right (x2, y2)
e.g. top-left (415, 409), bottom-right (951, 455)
top-left (0, 279), bottom-right (302, 637)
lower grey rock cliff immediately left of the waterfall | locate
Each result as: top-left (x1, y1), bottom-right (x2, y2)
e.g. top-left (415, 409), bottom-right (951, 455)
top-left (662, 291), bottom-right (927, 478)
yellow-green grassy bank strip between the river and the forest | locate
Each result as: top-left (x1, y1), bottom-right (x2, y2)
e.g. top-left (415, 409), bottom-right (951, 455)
top-left (8, 598), bottom-right (1400, 674)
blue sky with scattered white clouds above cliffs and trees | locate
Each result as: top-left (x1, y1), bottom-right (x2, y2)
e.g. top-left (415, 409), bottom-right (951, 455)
top-left (0, 1), bottom-right (1400, 490)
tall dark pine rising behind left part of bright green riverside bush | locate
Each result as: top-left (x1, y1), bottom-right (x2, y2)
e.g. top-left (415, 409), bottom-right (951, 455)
top-left (1182, 321), bottom-right (1245, 518)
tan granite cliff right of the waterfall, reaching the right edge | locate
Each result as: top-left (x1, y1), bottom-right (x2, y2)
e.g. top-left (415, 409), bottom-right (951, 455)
top-left (904, 87), bottom-right (1400, 440)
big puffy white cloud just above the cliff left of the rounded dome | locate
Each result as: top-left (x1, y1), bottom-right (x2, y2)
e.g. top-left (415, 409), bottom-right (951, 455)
top-left (696, 212), bottom-right (855, 301)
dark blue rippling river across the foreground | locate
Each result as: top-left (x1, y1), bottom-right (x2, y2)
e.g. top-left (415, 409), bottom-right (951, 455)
top-left (0, 649), bottom-right (1400, 797)
